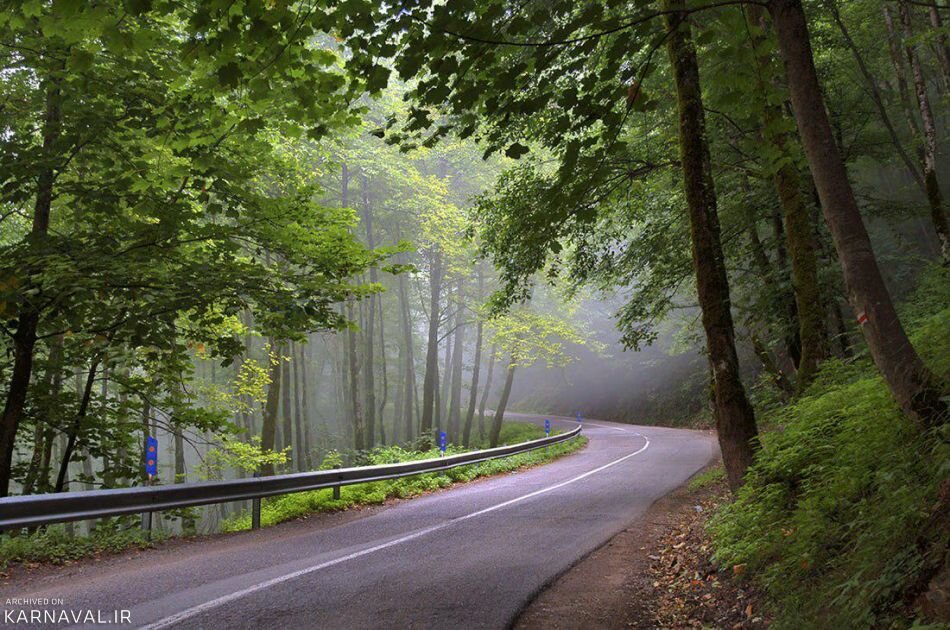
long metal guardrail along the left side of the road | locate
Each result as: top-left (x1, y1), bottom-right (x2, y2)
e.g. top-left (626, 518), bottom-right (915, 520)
top-left (0, 426), bottom-right (581, 531)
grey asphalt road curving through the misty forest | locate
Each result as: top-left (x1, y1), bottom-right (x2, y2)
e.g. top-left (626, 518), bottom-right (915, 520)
top-left (0, 419), bottom-right (715, 630)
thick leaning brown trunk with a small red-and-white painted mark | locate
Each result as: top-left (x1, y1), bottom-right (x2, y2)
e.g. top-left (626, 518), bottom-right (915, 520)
top-left (769, 0), bottom-right (946, 425)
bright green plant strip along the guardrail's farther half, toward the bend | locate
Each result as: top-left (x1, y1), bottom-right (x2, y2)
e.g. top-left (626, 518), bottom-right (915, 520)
top-left (223, 432), bottom-right (587, 531)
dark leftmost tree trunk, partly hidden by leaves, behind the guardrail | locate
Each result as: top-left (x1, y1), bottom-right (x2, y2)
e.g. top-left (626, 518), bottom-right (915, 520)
top-left (0, 70), bottom-right (62, 497)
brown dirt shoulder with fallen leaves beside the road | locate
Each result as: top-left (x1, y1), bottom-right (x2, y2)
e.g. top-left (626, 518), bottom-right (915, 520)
top-left (514, 464), bottom-right (769, 630)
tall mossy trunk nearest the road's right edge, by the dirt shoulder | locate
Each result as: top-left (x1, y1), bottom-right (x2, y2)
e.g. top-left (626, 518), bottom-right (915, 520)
top-left (663, 0), bottom-right (758, 490)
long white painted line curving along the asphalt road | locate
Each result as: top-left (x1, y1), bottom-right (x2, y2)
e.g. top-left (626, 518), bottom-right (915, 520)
top-left (142, 429), bottom-right (650, 630)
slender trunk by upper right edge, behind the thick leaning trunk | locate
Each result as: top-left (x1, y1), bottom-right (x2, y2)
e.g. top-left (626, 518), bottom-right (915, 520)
top-left (897, 0), bottom-right (950, 263)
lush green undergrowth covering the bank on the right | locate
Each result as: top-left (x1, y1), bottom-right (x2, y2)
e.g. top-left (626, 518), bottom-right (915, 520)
top-left (710, 273), bottom-right (950, 628)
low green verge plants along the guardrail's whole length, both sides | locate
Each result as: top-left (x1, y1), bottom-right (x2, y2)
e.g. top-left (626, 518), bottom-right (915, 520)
top-left (0, 422), bottom-right (587, 578)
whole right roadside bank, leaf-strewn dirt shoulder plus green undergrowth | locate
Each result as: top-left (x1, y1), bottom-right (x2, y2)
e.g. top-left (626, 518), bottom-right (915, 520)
top-left (520, 268), bottom-right (950, 628)
